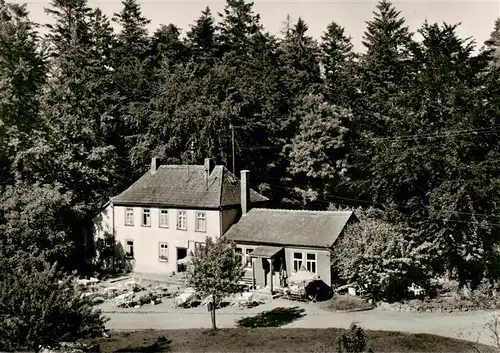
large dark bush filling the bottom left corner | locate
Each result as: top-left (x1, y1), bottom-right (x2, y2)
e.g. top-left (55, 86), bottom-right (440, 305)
top-left (0, 253), bottom-right (106, 352)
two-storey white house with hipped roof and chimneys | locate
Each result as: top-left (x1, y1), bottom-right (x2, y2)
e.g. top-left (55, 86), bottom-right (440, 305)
top-left (95, 158), bottom-right (268, 274)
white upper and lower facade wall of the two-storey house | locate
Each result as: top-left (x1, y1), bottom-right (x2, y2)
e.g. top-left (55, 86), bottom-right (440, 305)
top-left (96, 206), bottom-right (222, 274)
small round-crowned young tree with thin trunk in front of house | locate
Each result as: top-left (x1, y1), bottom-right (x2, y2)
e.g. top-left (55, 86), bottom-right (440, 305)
top-left (186, 237), bottom-right (244, 330)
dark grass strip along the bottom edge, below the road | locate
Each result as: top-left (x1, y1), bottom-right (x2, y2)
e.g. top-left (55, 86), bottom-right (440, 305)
top-left (82, 327), bottom-right (497, 353)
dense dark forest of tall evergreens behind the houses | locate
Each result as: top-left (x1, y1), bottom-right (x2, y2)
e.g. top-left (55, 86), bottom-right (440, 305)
top-left (0, 0), bottom-right (500, 308)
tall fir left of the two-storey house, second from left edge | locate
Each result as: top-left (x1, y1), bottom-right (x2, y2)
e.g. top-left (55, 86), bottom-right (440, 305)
top-left (16, 0), bottom-right (118, 270)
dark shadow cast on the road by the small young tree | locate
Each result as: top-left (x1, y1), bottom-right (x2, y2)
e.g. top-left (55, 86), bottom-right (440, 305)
top-left (236, 306), bottom-right (305, 328)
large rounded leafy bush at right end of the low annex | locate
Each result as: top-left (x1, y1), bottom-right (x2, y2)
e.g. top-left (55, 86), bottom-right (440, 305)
top-left (332, 208), bottom-right (431, 302)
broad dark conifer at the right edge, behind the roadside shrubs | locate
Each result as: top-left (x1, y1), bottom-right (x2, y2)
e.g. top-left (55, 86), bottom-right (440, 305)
top-left (367, 23), bottom-right (500, 285)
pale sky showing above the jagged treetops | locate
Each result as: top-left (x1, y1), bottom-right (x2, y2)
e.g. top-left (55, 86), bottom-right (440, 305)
top-left (10, 0), bottom-right (500, 51)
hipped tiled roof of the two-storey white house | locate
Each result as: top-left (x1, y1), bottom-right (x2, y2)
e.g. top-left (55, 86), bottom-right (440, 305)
top-left (111, 165), bottom-right (268, 208)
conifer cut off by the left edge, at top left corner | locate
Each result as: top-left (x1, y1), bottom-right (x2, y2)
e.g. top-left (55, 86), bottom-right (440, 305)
top-left (0, 0), bottom-right (45, 186)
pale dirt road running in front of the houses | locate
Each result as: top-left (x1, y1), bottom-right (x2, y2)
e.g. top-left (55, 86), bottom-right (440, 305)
top-left (104, 300), bottom-right (500, 344)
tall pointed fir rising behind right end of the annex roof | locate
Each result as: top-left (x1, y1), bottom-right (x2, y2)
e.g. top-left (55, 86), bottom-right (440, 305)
top-left (346, 0), bottom-right (416, 201)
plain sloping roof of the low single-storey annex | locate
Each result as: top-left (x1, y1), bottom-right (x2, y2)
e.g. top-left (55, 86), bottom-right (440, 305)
top-left (224, 208), bottom-right (355, 248)
